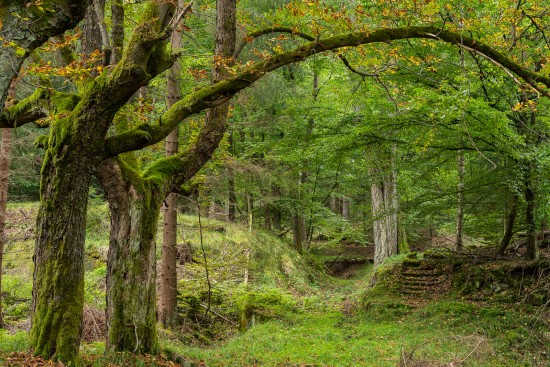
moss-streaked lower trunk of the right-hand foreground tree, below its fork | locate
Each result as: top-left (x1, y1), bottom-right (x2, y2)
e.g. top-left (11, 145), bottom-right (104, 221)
top-left (98, 158), bottom-right (164, 353)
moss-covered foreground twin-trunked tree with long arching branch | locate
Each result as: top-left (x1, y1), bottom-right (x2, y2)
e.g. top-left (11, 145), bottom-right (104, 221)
top-left (0, 0), bottom-right (550, 363)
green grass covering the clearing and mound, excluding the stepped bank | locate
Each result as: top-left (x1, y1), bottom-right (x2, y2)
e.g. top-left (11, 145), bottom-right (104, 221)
top-left (0, 204), bottom-right (550, 367)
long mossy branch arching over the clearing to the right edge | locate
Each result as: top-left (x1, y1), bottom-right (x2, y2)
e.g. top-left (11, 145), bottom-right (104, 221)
top-left (104, 26), bottom-right (550, 158)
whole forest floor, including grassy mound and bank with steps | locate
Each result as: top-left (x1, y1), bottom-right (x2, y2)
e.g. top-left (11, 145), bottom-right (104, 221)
top-left (0, 204), bottom-right (550, 367)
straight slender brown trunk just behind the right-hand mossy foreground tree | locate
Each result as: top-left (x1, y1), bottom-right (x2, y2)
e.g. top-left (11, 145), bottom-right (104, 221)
top-left (158, 1), bottom-right (185, 328)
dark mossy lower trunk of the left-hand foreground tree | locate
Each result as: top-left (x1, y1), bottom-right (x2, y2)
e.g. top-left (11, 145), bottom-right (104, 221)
top-left (30, 121), bottom-right (95, 362)
